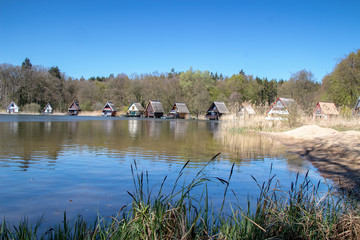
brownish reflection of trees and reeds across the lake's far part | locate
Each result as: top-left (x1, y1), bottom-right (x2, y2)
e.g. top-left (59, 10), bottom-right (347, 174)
top-left (0, 119), bottom-right (310, 170)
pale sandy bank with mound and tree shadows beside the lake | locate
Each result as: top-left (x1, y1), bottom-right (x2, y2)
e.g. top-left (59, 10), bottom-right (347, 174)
top-left (262, 125), bottom-right (360, 196)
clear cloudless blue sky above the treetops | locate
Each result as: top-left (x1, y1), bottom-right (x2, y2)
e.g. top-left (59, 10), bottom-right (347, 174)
top-left (0, 0), bottom-right (360, 81)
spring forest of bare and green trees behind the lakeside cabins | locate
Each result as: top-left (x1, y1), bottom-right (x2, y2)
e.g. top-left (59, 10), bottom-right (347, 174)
top-left (0, 50), bottom-right (360, 115)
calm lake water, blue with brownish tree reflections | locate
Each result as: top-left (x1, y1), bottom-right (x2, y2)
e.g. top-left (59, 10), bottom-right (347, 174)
top-left (0, 115), bottom-right (322, 223)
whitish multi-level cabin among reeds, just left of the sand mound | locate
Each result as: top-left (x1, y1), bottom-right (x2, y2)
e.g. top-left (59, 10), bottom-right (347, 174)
top-left (265, 97), bottom-right (296, 120)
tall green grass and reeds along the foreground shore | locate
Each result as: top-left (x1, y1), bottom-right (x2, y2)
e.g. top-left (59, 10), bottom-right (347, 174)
top-left (0, 156), bottom-right (360, 239)
